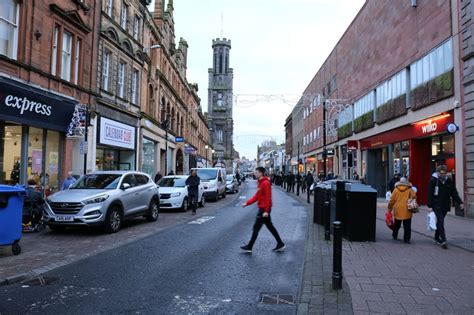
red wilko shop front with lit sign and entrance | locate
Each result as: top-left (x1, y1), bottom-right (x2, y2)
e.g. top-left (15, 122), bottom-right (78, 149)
top-left (360, 112), bottom-right (456, 204)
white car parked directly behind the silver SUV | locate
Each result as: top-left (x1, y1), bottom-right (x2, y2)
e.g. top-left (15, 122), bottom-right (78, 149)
top-left (158, 175), bottom-right (206, 211)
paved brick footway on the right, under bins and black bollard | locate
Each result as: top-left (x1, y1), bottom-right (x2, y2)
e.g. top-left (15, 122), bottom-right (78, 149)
top-left (284, 184), bottom-right (474, 314)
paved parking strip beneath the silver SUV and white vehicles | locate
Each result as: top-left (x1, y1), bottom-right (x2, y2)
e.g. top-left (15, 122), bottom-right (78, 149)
top-left (0, 190), bottom-right (240, 285)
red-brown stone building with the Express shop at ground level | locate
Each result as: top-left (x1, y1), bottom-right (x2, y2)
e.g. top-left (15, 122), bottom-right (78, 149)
top-left (0, 0), bottom-right (100, 188)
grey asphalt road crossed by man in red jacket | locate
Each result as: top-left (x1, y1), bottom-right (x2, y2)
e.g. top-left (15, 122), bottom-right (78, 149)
top-left (0, 182), bottom-right (308, 315)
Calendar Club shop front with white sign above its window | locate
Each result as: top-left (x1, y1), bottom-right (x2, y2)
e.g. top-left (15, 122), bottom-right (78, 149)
top-left (95, 116), bottom-right (136, 171)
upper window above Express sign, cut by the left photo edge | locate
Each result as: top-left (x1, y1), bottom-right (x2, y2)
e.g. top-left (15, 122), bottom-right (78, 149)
top-left (0, 0), bottom-right (19, 59)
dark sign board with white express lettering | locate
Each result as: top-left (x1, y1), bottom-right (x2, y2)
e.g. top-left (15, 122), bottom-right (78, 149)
top-left (0, 77), bottom-right (77, 132)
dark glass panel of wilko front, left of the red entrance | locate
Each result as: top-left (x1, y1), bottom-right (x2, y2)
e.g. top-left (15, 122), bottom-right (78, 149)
top-left (367, 148), bottom-right (390, 197)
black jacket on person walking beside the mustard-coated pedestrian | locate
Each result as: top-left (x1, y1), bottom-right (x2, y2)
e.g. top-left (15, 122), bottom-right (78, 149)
top-left (428, 173), bottom-right (462, 213)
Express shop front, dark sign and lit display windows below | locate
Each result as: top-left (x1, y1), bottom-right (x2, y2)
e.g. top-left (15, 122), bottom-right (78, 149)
top-left (0, 77), bottom-right (82, 193)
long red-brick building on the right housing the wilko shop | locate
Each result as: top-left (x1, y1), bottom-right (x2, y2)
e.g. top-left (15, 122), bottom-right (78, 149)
top-left (303, 0), bottom-right (464, 210)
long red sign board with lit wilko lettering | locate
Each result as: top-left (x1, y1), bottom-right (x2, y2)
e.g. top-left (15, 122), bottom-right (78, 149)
top-left (360, 114), bottom-right (454, 150)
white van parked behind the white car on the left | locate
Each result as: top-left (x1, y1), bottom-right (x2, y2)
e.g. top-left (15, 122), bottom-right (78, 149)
top-left (191, 167), bottom-right (226, 201)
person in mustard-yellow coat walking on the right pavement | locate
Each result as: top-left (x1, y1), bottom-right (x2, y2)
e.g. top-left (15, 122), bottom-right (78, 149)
top-left (388, 177), bottom-right (416, 244)
